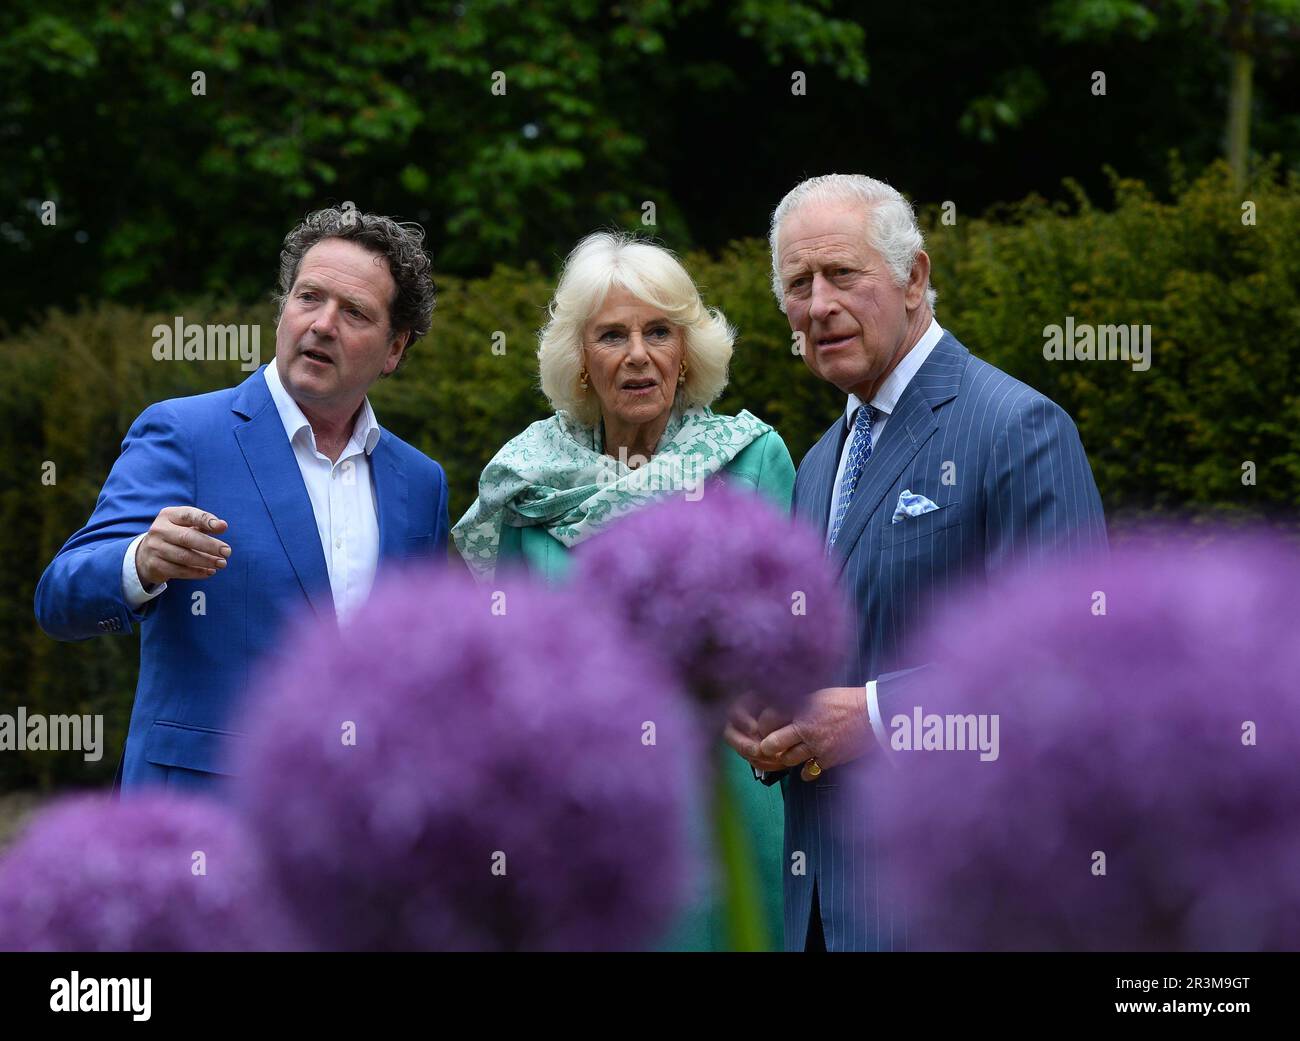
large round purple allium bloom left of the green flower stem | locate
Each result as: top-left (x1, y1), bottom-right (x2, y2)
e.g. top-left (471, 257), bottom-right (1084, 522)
top-left (237, 568), bottom-right (699, 950)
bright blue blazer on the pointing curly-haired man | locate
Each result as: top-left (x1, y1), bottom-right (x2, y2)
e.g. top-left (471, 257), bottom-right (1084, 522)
top-left (36, 366), bottom-right (449, 788)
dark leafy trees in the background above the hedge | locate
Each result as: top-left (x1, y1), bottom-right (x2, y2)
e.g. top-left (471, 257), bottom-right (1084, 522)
top-left (0, 0), bottom-right (1300, 329)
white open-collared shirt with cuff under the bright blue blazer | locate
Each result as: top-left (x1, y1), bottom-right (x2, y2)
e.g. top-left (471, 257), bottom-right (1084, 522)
top-left (122, 360), bottom-right (381, 623)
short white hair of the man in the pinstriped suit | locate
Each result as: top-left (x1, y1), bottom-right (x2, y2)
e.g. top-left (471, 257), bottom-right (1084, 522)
top-left (767, 174), bottom-right (939, 311)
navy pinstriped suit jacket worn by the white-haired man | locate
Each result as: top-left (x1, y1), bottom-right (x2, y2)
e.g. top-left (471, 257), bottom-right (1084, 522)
top-left (768, 333), bottom-right (1106, 950)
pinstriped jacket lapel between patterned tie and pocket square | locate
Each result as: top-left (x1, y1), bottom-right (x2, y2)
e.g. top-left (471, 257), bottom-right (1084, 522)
top-left (833, 333), bottom-right (970, 573)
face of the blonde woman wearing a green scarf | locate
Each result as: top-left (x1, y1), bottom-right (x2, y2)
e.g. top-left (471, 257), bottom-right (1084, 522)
top-left (582, 287), bottom-right (685, 426)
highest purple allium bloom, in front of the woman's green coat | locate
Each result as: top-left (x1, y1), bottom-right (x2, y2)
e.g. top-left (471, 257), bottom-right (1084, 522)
top-left (575, 481), bottom-right (848, 713)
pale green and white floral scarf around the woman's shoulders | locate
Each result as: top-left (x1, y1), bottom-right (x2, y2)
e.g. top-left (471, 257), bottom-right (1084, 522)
top-left (451, 408), bottom-right (772, 580)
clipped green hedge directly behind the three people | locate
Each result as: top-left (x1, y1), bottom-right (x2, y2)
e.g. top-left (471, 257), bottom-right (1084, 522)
top-left (0, 162), bottom-right (1300, 786)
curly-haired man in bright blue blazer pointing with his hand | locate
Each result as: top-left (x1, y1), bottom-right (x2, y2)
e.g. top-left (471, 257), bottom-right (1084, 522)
top-left (35, 209), bottom-right (447, 789)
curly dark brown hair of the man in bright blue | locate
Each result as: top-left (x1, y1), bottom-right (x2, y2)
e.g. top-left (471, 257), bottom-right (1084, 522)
top-left (276, 207), bottom-right (434, 369)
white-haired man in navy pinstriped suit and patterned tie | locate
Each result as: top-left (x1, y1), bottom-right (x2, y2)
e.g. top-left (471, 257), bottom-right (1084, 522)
top-left (727, 174), bottom-right (1106, 950)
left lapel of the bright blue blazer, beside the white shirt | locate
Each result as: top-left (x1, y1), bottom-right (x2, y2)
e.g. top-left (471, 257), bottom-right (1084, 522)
top-left (233, 369), bottom-right (337, 621)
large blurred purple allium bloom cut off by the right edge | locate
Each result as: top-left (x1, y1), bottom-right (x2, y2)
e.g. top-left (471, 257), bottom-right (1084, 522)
top-left (865, 537), bottom-right (1300, 950)
